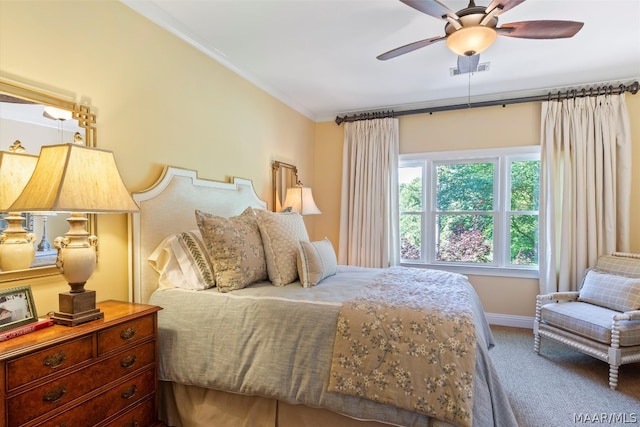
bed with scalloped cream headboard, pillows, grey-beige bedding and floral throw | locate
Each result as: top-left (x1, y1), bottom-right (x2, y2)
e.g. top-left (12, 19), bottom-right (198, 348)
top-left (131, 167), bottom-right (517, 427)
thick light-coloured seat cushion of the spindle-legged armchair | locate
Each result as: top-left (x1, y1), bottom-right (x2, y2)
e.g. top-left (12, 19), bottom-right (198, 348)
top-left (540, 302), bottom-right (640, 347)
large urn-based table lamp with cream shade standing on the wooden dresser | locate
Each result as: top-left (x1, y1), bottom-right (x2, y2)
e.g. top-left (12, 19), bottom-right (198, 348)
top-left (11, 143), bottom-right (139, 326)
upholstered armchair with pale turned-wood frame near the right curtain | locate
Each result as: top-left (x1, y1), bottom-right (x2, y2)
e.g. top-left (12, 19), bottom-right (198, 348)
top-left (533, 252), bottom-right (640, 390)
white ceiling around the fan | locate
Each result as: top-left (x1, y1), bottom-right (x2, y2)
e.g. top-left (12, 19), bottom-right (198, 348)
top-left (121, 0), bottom-right (640, 121)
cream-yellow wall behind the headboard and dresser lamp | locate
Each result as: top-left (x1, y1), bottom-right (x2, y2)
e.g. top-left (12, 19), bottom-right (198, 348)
top-left (0, 0), bottom-right (315, 314)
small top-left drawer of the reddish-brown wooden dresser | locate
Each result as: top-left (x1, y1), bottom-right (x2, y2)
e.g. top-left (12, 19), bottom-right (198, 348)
top-left (6, 336), bottom-right (93, 392)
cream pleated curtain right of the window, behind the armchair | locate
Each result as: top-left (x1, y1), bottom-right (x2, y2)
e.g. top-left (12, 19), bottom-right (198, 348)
top-left (539, 94), bottom-right (631, 293)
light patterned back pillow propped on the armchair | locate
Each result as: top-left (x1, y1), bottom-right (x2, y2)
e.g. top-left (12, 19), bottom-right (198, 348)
top-left (578, 270), bottom-right (640, 311)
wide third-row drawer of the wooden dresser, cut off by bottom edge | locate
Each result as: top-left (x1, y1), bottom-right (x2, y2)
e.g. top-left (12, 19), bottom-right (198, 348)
top-left (38, 369), bottom-right (156, 427)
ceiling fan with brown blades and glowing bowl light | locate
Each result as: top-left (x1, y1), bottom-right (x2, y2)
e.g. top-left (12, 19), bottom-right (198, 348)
top-left (377, 0), bottom-right (584, 61)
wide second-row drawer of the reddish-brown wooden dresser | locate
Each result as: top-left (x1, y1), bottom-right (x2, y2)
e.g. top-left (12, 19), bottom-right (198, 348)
top-left (8, 341), bottom-right (155, 426)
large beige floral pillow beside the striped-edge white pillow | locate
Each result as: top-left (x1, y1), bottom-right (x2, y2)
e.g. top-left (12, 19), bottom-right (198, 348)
top-left (196, 208), bottom-right (267, 292)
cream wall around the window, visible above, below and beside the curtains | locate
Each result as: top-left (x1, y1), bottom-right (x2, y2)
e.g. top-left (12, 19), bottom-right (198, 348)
top-left (314, 94), bottom-right (640, 317)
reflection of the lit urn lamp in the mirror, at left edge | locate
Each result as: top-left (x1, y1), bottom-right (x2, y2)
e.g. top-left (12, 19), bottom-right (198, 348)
top-left (0, 151), bottom-right (38, 271)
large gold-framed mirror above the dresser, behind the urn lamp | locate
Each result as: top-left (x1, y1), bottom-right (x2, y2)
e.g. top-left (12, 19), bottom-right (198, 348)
top-left (0, 77), bottom-right (97, 282)
